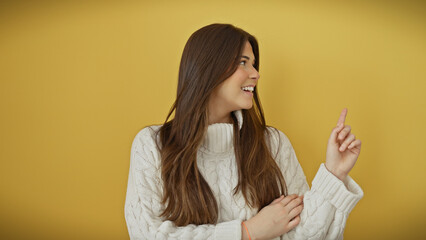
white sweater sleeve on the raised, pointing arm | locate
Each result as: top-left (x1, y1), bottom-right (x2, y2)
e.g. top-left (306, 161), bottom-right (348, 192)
top-left (266, 128), bottom-right (364, 240)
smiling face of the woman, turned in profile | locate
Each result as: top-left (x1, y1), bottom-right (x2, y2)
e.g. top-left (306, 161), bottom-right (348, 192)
top-left (210, 42), bottom-right (260, 112)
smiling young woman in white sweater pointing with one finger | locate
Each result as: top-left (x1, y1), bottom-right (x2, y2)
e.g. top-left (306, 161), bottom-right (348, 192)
top-left (125, 24), bottom-right (363, 240)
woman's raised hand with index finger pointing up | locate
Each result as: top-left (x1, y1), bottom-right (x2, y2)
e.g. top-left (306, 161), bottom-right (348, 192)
top-left (325, 108), bottom-right (361, 181)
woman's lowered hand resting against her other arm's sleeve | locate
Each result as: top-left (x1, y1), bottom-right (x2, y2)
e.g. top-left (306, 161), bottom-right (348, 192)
top-left (243, 194), bottom-right (303, 240)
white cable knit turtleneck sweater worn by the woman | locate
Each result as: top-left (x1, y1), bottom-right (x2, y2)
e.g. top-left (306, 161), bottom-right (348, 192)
top-left (125, 111), bottom-right (363, 240)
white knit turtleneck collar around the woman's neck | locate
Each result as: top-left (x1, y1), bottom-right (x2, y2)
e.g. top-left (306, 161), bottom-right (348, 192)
top-left (201, 110), bottom-right (243, 153)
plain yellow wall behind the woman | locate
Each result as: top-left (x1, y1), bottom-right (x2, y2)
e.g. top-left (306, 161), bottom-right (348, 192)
top-left (0, 0), bottom-right (426, 239)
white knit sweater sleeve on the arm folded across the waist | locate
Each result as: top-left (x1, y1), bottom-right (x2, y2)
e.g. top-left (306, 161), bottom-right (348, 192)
top-left (124, 127), bottom-right (241, 240)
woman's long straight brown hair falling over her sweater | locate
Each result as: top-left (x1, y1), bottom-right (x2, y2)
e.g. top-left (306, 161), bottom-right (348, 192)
top-left (158, 24), bottom-right (287, 226)
